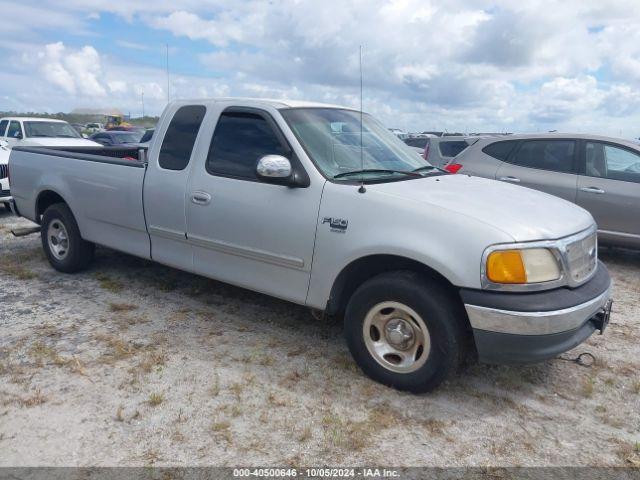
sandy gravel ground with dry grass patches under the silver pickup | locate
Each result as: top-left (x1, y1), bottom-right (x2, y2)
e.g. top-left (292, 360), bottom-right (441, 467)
top-left (0, 208), bottom-right (640, 467)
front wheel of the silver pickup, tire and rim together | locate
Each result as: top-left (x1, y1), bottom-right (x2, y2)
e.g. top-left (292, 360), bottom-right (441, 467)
top-left (345, 271), bottom-right (464, 393)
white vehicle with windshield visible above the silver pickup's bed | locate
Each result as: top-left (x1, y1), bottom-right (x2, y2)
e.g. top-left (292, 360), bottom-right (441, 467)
top-left (0, 117), bottom-right (98, 148)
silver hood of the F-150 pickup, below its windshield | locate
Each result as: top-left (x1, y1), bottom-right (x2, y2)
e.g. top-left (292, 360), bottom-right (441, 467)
top-left (367, 175), bottom-right (594, 242)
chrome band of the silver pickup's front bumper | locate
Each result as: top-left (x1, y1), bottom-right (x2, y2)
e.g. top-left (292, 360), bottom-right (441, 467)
top-left (465, 288), bottom-right (611, 335)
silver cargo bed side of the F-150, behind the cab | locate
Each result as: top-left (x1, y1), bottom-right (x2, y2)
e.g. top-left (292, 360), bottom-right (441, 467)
top-left (9, 147), bottom-right (150, 258)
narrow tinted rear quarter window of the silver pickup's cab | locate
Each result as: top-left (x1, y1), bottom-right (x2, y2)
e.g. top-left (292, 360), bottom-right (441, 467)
top-left (158, 105), bottom-right (207, 171)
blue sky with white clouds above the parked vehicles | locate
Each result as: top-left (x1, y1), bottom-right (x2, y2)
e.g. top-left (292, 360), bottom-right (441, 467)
top-left (0, 0), bottom-right (640, 138)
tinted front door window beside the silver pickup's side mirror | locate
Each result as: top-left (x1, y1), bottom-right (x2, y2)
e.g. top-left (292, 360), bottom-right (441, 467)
top-left (206, 112), bottom-right (289, 180)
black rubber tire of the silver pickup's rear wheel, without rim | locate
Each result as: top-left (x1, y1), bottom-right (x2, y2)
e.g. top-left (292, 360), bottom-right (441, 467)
top-left (40, 203), bottom-right (95, 273)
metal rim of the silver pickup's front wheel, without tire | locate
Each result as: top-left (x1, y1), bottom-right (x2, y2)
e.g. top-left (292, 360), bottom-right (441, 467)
top-left (362, 302), bottom-right (431, 373)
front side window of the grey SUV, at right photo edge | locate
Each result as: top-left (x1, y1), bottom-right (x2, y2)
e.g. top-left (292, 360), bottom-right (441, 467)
top-left (585, 142), bottom-right (640, 183)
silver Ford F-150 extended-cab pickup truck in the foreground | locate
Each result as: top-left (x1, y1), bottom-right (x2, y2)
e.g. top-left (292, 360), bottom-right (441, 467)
top-left (9, 99), bottom-right (611, 392)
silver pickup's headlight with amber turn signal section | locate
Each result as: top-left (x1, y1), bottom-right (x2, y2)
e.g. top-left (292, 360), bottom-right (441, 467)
top-left (486, 248), bottom-right (561, 284)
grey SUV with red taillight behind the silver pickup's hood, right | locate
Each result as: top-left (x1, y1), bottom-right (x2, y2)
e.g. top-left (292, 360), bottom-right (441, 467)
top-left (446, 133), bottom-right (640, 248)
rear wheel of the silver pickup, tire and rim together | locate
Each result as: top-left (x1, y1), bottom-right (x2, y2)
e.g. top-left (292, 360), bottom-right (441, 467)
top-left (40, 203), bottom-right (94, 273)
